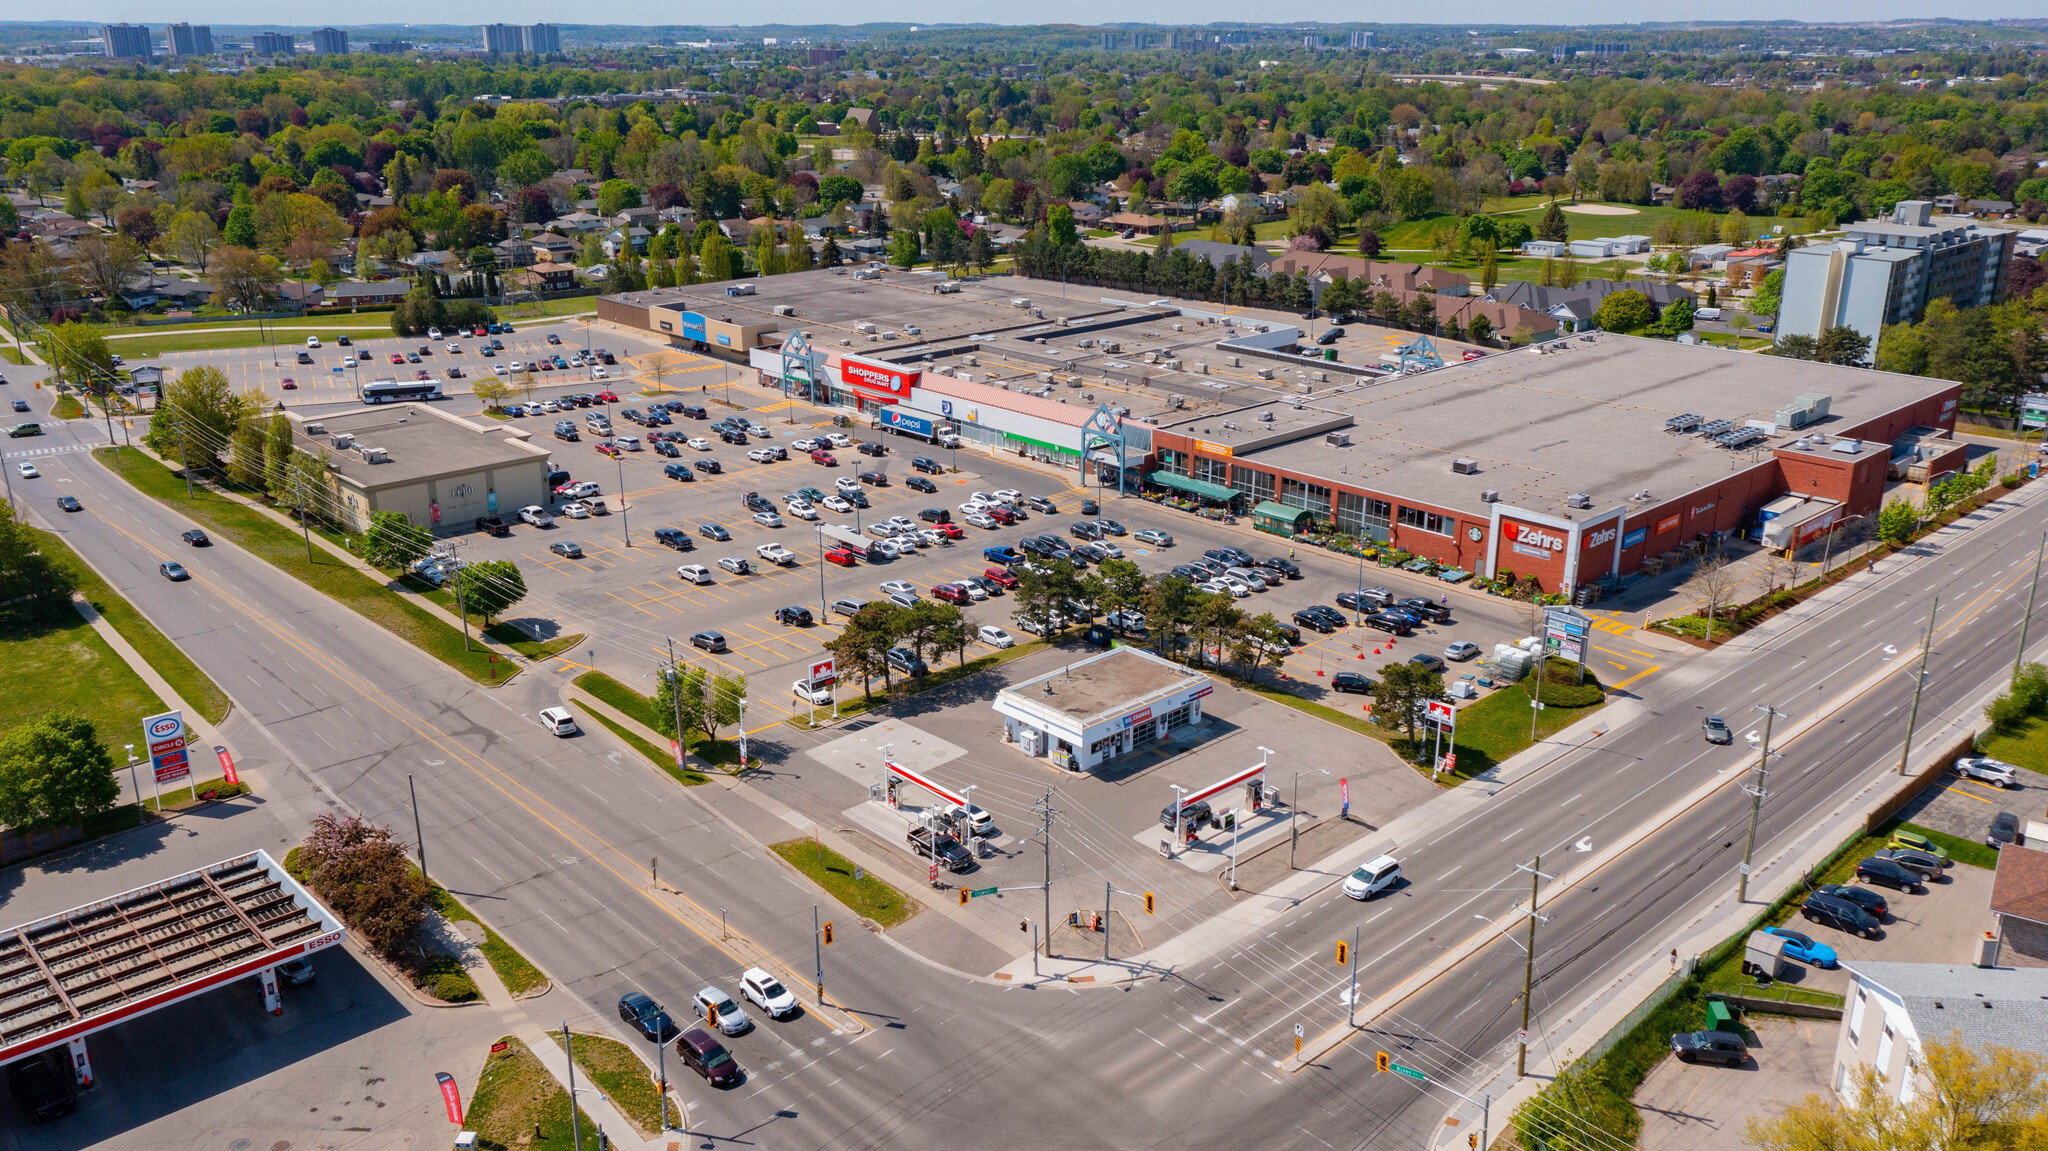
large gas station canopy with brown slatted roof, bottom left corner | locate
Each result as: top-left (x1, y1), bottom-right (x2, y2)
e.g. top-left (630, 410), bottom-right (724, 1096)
top-left (0, 852), bottom-right (344, 1065)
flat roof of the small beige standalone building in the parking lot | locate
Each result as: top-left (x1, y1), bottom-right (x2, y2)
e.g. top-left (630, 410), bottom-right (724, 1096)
top-left (291, 403), bottom-right (549, 487)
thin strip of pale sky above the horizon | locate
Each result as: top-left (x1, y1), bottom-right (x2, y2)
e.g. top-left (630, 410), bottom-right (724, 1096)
top-left (48, 0), bottom-right (2042, 29)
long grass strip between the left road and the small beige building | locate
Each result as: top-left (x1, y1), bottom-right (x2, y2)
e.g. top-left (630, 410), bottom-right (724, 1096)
top-left (92, 449), bottom-right (518, 684)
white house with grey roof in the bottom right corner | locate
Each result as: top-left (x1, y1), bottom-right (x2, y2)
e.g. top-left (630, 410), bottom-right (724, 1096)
top-left (1829, 958), bottom-right (2048, 1104)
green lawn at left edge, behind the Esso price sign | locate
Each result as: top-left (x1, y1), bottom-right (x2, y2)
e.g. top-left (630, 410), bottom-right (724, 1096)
top-left (0, 608), bottom-right (166, 749)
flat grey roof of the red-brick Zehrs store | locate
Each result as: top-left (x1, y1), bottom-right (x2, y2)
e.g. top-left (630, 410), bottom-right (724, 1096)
top-left (1196, 334), bottom-right (1925, 516)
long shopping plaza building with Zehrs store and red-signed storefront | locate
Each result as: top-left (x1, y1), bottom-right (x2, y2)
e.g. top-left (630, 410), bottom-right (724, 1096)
top-left (600, 268), bottom-right (1964, 592)
